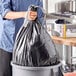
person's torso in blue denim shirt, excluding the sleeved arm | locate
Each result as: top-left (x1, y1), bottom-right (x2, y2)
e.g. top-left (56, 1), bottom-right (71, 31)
top-left (0, 0), bottom-right (38, 52)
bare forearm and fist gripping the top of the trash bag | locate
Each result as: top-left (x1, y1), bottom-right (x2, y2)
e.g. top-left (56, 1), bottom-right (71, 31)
top-left (4, 11), bottom-right (37, 20)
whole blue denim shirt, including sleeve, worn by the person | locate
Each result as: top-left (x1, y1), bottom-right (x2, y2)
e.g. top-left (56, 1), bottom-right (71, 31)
top-left (0, 0), bottom-right (43, 52)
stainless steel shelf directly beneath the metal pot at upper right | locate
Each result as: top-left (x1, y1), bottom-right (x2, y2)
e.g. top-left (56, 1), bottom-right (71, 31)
top-left (46, 13), bottom-right (76, 24)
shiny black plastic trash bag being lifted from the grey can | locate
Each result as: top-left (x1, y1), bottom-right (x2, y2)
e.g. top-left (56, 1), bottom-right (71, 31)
top-left (13, 5), bottom-right (59, 67)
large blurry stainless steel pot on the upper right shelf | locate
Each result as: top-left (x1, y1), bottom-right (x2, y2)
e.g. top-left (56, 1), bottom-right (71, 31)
top-left (55, 0), bottom-right (76, 13)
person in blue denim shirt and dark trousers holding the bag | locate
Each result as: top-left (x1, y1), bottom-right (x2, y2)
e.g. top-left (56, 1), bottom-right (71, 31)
top-left (0, 0), bottom-right (43, 76)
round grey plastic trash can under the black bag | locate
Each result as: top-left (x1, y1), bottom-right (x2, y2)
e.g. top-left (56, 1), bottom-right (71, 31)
top-left (11, 62), bottom-right (63, 76)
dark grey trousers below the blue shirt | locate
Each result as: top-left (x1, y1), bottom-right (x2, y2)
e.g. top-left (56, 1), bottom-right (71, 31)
top-left (0, 49), bottom-right (12, 76)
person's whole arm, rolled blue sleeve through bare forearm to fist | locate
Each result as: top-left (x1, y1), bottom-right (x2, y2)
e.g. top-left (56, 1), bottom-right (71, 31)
top-left (0, 0), bottom-right (37, 20)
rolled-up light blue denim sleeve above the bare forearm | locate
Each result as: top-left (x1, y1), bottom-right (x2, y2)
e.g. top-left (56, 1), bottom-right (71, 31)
top-left (0, 0), bottom-right (11, 18)
